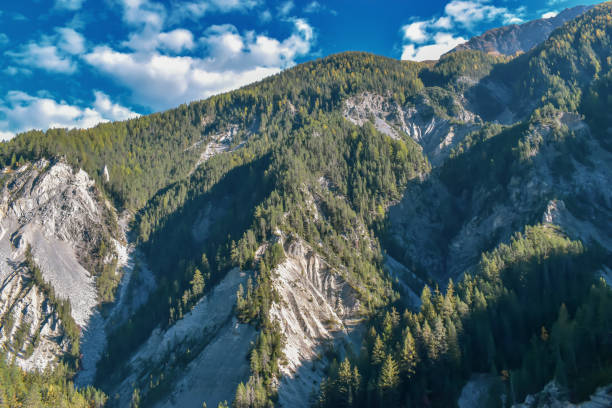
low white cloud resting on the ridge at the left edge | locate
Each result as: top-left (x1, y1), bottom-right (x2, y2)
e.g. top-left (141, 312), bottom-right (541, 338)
top-left (0, 91), bottom-right (138, 139)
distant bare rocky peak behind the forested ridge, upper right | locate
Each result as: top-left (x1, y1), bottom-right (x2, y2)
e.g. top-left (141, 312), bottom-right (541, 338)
top-left (450, 6), bottom-right (591, 55)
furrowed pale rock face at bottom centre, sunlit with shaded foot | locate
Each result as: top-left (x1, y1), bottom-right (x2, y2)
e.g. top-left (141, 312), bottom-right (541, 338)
top-left (270, 239), bottom-right (360, 407)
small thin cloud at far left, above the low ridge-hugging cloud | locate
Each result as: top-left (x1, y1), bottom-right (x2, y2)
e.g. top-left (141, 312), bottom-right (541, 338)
top-left (6, 42), bottom-right (76, 74)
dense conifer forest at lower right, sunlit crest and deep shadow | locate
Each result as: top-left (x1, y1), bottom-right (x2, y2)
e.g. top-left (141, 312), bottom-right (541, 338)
top-left (318, 226), bottom-right (612, 407)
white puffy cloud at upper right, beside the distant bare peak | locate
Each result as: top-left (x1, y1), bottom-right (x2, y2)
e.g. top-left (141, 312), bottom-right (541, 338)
top-left (401, 0), bottom-right (524, 61)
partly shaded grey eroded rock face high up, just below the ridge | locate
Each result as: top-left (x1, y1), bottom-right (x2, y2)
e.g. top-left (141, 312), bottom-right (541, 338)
top-left (343, 92), bottom-right (480, 166)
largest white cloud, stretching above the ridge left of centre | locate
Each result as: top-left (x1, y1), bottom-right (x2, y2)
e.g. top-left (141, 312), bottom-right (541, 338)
top-left (84, 19), bottom-right (314, 109)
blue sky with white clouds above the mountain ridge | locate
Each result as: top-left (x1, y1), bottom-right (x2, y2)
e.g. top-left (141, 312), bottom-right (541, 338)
top-left (0, 0), bottom-right (596, 139)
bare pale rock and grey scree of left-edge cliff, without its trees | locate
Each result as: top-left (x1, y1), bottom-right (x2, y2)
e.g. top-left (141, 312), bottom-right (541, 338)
top-left (0, 160), bottom-right (119, 369)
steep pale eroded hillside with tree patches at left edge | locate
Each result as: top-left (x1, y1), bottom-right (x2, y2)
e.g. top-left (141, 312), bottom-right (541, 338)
top-left (0, 159), bottom-right (123, 370)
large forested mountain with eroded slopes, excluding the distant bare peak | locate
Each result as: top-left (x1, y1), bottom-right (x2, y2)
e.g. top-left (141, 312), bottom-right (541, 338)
top-left (0, 3), bottom-right (612, 407)
